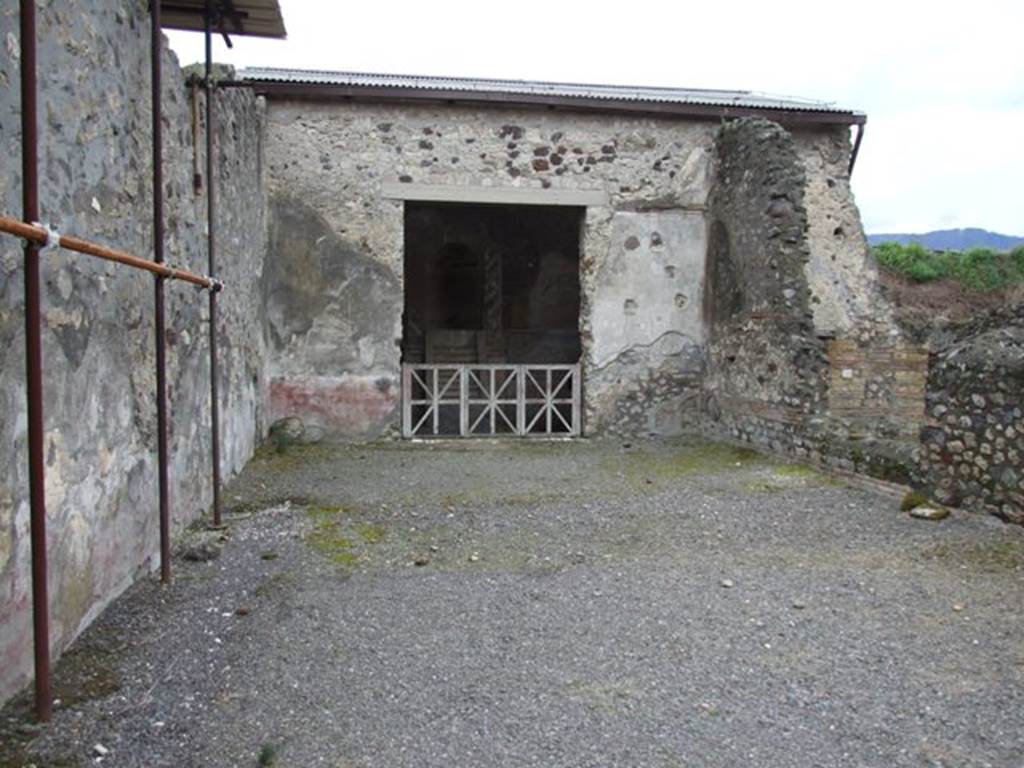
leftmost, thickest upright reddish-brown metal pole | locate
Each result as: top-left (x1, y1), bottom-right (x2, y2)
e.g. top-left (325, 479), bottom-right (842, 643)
top-left (20, 0), bottom-right (53, 722)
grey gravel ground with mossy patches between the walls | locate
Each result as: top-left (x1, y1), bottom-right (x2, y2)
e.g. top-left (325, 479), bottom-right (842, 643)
top-left (0, 440), bottom-right (1024, 768)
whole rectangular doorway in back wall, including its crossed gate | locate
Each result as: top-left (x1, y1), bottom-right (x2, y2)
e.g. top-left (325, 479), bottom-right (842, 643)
top-left (401, 202), bottom-right (585, 437)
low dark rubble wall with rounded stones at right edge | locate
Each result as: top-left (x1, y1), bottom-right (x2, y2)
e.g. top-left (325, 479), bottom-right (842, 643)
top-left (918, 304), bottom-right (1024, 523)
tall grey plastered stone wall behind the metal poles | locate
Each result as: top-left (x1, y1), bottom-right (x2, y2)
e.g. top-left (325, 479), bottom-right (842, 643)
top-left (0, 0), bottom-right (265, 700)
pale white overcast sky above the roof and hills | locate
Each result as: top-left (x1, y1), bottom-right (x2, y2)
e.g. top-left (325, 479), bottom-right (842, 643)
top-left (170, 0), bottom-right (1024, 236)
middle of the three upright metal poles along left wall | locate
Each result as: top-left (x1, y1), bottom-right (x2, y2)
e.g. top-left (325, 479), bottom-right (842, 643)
top-left (150, 0), bottom-right (171, 584)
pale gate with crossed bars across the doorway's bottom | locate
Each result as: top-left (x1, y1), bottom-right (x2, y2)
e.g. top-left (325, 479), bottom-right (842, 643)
top-left (401, 364), bottom-right (580, 437)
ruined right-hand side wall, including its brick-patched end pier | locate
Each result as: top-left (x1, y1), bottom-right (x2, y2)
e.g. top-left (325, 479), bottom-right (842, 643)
top-left (703, 120), bottom-right (928, 482)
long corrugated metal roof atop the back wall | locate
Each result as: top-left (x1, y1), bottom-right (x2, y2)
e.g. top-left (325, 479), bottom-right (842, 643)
top-left (239, 67), bottom-right (859, 115)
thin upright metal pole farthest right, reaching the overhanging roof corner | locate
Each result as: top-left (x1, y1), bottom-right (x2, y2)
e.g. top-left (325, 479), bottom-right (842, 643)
top-left (206, 0), bottom-right (221, 525)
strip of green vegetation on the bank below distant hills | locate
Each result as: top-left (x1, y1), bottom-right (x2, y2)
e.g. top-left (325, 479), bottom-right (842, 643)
top-left (871, 243), bottom-right (1024, 291)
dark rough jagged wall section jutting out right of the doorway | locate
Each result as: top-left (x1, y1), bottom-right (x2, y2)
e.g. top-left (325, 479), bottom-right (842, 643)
top-left (705, 120), bottom-right (828, 456)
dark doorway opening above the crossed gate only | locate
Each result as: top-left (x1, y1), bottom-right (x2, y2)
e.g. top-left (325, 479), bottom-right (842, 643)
top-left (401, 202), bottom-right (584, 365)
